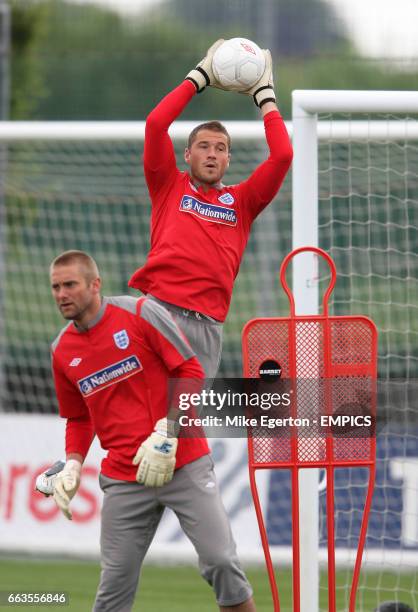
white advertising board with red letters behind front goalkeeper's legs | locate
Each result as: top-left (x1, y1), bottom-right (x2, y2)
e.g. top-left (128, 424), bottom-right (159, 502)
top-left (0, 414), bottom-right (268, 561)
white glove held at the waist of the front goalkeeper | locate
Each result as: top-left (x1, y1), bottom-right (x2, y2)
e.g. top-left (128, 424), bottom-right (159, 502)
top-left (132, 419), bottom-right (177, 487)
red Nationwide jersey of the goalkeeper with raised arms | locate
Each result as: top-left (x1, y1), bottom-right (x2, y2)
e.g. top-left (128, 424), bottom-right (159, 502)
top-left (129, 81), bottom-right (292, 321)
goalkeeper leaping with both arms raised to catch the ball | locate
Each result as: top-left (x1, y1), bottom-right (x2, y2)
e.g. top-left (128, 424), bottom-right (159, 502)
top-left (129, 40), bottom-right (292, 378)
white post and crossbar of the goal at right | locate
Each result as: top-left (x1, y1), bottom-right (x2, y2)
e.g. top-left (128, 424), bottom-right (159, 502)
top-left (292, 90), bottom-right (418, 612)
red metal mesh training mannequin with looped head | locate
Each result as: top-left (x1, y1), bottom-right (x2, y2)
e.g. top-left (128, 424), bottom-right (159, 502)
top-left (242, 246), bottom-right (377, 612)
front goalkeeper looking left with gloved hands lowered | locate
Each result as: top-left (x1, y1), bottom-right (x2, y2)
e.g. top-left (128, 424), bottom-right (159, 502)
top-left (37, 251), bottom-right (255, 612)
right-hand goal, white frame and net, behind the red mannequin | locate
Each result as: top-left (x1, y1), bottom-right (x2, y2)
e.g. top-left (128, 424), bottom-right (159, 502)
top-left (288, 91), bottom-right (418, 610)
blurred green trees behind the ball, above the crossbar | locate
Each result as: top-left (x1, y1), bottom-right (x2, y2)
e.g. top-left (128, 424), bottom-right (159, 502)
top-left (9, 0), bottom-right (418, 120)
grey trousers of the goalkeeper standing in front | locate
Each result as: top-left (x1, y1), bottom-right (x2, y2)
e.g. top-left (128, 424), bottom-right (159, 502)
top-left (94, 455), bottom-right (252, 612)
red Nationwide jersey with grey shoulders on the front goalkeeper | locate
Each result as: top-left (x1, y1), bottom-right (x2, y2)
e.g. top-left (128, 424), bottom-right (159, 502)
top-left (52, 296), bottom-right (209, 481)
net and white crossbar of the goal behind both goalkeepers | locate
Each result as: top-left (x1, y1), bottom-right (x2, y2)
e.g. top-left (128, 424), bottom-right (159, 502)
top-left (0, 122), bottom-right (291, 412)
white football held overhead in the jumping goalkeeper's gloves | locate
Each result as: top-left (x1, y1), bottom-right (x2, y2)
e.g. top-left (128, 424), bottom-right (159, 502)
top-left (212, 38), bottom-right (266, 91)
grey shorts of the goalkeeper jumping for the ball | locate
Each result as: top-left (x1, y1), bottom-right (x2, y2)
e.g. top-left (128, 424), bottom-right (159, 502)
top-left (147, 294), bottom-right (222, 379)
